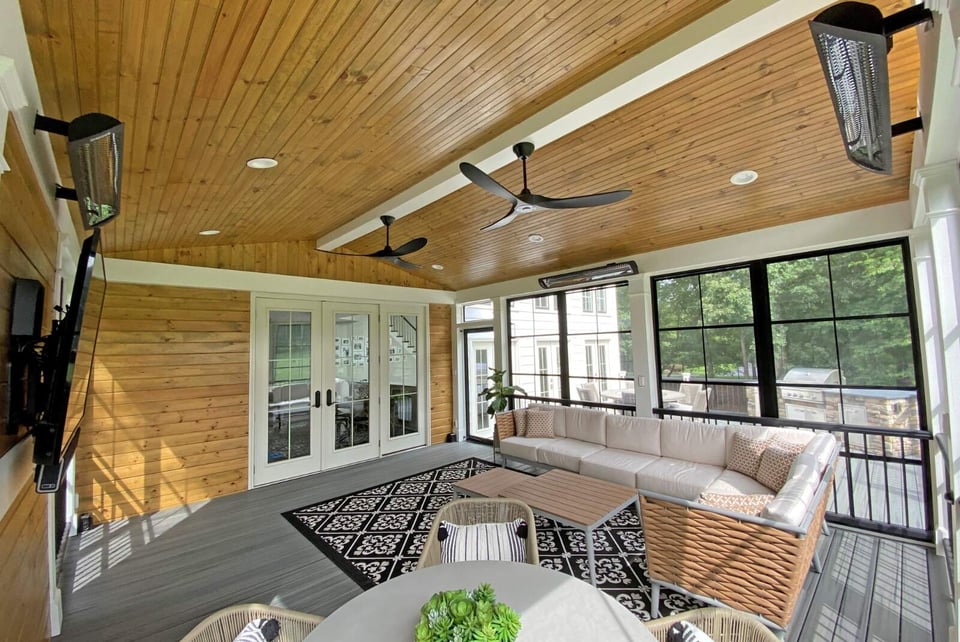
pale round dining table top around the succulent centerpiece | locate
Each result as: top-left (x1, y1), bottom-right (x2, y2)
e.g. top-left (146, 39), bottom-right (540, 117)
top-left (305, 562), bottom-right (655, 642)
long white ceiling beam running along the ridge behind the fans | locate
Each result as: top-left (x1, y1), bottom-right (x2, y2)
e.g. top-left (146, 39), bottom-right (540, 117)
top-left (317, 0), bottom-right (833, 250)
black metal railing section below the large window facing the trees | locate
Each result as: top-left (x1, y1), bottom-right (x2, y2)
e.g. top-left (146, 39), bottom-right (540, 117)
top-left (653, 408), bottom-right (933, 541)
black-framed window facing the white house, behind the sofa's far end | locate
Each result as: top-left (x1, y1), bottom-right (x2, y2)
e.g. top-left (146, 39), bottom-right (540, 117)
top-left (508, 283), bottom-right (634, 405)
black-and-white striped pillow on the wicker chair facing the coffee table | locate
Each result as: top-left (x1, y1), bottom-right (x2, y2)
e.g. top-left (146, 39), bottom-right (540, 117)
top-left (437, 519), bottom-right (527, 564)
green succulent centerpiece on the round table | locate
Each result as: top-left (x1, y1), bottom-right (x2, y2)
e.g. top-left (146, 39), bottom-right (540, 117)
top-left (414, 584), bottom-right (520, 642)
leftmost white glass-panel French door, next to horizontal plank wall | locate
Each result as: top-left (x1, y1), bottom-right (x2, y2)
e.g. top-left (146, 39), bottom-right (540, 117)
top-left (253, 299), bottom-right (320, 485)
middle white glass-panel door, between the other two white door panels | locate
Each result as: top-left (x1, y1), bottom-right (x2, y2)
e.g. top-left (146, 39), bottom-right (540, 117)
top-left (323, 303), bottom-right (380, 469)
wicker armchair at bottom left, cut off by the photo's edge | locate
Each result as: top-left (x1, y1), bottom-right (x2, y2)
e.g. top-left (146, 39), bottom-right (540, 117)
top-left (180, 604), bottom-right (323, 642)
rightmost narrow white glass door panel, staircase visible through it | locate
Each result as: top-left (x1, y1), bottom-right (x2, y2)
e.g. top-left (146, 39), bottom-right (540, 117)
top-left (380, 306), bottom-right (427, 453)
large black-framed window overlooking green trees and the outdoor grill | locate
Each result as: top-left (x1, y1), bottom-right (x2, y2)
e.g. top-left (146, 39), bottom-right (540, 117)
top-left (652, 240), bottom-right (924, 428)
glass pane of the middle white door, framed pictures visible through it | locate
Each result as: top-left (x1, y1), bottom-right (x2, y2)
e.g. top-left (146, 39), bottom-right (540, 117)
top-left (333, 312), bottom-right (370, 450)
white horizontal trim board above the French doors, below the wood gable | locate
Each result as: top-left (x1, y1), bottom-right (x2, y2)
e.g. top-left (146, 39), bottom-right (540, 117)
top-left (106, 258), bottom-right (455, 304)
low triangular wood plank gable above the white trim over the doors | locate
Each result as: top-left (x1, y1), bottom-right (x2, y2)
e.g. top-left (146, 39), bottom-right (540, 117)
top-left (106, 241), bottom-right (442, 289)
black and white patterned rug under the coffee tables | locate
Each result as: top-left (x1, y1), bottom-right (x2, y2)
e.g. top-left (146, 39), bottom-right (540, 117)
top-left (283, 458), bottom-right (704, 620)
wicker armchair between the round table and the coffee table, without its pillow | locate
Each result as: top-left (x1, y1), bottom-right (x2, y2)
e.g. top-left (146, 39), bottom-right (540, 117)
top-left (417, 498), bottom-right (540, 568)
